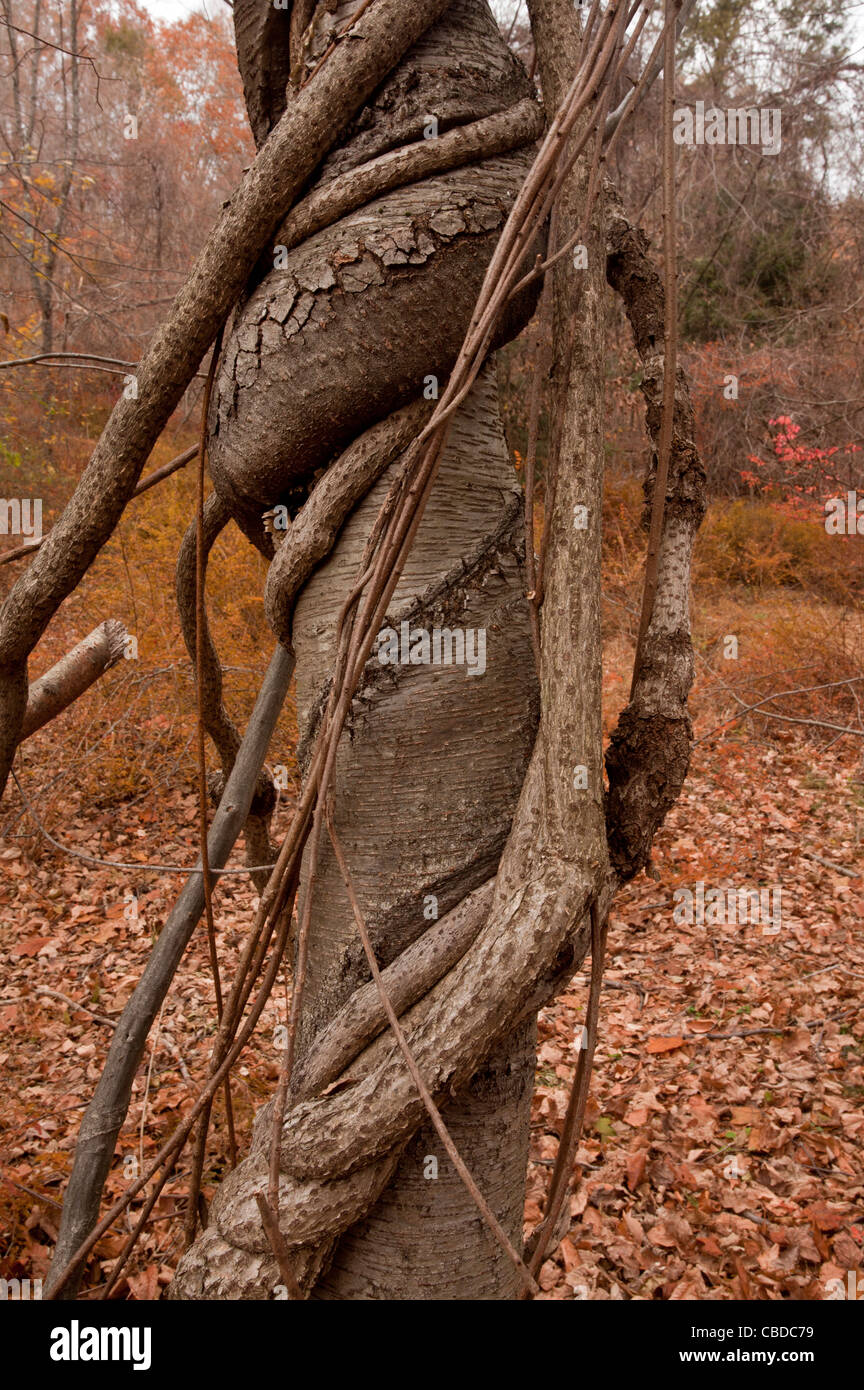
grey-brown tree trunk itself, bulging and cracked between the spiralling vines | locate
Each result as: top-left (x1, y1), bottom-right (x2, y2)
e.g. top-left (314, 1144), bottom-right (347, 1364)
top-left (173, 0), bottom-right (538, 1300)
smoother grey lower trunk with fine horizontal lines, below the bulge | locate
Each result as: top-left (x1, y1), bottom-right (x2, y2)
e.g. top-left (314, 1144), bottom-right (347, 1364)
top-left (294, 366), bottom-right (536, 1300)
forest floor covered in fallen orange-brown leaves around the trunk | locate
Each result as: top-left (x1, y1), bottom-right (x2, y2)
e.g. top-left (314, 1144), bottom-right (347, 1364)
top-left (0, 567), bottom-right (864, 1300)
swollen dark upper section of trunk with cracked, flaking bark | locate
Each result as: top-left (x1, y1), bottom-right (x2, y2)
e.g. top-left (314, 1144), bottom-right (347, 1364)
top-left (210, 0), bottom-right (533, 539)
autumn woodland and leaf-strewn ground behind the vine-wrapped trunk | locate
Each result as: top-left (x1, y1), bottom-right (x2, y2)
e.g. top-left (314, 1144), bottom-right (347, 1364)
top-left (0, 0), bottom-right (864, 1298)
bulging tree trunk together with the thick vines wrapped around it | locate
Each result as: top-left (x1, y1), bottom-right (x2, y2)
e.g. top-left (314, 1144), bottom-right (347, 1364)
top-left (40, 0), bottom-right (701, 1300)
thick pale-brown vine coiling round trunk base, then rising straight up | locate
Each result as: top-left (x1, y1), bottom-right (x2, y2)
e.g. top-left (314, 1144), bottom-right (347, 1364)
top-left (169, 143), bottom-right (701, 1297)
